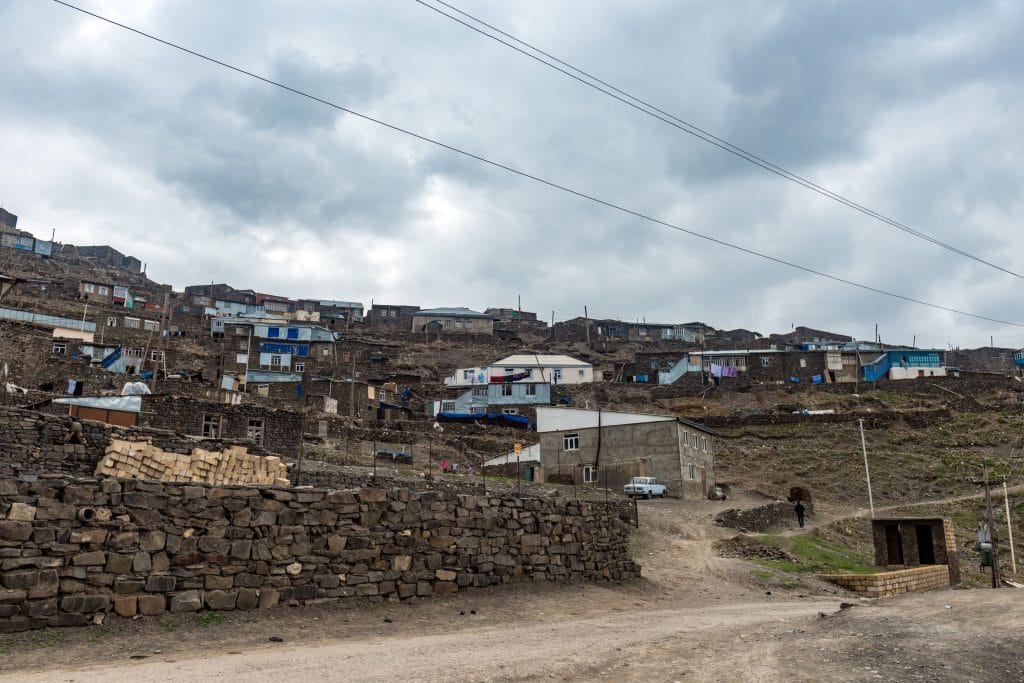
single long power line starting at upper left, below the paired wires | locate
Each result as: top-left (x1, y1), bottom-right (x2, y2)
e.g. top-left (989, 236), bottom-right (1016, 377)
top-left (46, 0), bottom-right (1024, 328)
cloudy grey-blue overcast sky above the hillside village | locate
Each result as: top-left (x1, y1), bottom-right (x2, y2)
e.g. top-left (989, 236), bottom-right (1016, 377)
top-left (0, 0), bottom-right (1024, 347)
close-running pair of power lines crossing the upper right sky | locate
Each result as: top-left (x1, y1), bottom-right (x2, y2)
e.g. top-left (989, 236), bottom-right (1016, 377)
top-left (413, 0), bottom-right (1024, 280)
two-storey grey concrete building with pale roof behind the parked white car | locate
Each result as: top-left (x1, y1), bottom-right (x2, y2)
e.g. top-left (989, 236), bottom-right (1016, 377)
top-left (537, 407), bottom-right (716, 498)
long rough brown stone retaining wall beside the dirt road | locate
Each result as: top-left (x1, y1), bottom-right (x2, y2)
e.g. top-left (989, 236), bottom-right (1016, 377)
top-left (0, 476), bottom-right (640, 632)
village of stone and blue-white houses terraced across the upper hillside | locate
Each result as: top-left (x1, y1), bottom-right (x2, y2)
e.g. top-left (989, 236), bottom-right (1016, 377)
top-left (0, 205), bottom-right (1024, 483)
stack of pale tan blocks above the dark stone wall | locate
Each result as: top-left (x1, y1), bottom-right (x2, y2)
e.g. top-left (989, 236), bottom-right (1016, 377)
top-left (96, 438), bottom-right (289, 486)
